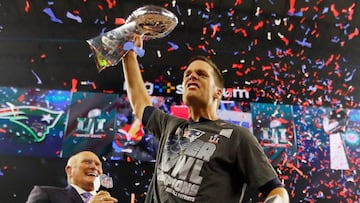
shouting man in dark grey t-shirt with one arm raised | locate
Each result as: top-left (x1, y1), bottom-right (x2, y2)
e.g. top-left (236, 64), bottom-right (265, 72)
top-left (123, 36), bottom-right (289, 203)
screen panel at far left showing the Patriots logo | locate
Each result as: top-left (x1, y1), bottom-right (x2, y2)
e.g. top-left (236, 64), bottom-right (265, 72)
top-left (0, 87), bottom-right (71, 157)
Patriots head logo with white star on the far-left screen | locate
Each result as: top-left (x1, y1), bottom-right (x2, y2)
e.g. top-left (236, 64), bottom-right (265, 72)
top-left (0, 103), bottom-right (64, 142)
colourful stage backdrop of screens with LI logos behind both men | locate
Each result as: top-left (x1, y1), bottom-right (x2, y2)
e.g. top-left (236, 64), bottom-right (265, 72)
top-left (0, 87), bottom-right (360, 202)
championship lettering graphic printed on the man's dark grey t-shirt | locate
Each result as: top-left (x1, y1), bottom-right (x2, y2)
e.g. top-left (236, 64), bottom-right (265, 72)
top-left (157, 128), bottom-right (216, 202)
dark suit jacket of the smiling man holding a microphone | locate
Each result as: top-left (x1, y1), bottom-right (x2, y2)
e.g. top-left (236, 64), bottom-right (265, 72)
top-left (26, 185), bottom-right (84, 203)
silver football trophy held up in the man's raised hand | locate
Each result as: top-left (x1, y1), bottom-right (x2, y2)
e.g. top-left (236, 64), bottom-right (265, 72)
top-left (86, 5), bottom-right (178, 72)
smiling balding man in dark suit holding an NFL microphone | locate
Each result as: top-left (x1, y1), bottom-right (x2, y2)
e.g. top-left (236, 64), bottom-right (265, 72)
top-left (26, 151), bottom-right (117, 203)
